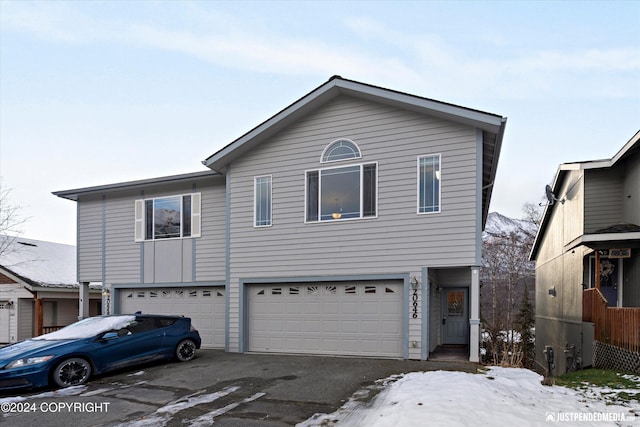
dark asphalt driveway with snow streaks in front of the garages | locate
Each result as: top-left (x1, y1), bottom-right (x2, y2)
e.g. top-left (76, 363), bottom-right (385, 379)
top-left (0, 350), bottom-right (478, 427)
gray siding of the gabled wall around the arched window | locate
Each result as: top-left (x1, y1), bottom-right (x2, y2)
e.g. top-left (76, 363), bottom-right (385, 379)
top-left (231, 98), bottom-right (477, 277)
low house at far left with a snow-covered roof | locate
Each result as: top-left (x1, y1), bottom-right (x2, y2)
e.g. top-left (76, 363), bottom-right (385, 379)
top-left (0, 235), bottom-right (101, 344)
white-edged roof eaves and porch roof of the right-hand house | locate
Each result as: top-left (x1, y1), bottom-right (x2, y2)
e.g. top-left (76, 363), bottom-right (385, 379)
top-left (529, 130), bottom-right (640, 260)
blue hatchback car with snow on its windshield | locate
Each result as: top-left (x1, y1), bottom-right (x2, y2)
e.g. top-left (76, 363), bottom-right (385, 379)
top-left (0, 313), bottom-right (201, 390)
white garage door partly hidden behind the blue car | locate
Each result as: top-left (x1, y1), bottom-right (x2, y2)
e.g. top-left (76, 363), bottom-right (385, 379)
top-left (119, 287), bottom-right (225, 348)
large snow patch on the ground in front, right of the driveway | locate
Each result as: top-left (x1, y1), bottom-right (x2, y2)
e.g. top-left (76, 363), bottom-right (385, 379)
top-left (298, 367), bottom-right (640, 427)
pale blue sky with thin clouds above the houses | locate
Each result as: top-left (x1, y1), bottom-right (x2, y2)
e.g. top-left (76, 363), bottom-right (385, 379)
top-left (0, 0), bottom-right (640, 244)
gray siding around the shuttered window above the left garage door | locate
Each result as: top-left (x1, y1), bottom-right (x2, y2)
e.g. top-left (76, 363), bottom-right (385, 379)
top-left (78, 178), bottom-right (225, 284)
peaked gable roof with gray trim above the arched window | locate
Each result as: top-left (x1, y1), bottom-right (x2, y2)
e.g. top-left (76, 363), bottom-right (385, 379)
top-left (202, 76), bottom-right (507, 225)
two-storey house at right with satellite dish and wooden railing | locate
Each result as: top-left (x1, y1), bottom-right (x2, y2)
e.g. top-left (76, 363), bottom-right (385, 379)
top-left (531, 132), bottom-right (640, 374)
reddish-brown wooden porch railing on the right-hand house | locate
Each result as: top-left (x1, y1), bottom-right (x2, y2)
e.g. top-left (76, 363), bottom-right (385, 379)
top-left (582, 288), bottom-right (640, 352)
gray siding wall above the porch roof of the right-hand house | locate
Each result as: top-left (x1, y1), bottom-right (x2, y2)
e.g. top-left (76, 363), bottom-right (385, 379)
top-left (584, 169), bottom-right (624, 233)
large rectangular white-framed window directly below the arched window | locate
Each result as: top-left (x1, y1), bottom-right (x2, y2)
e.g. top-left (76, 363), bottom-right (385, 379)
top-left (305, 163), bottom-right (378, 222)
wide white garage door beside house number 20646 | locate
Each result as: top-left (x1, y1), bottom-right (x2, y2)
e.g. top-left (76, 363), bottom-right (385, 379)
top-left (248, 282), bottom-right (403, 357)
